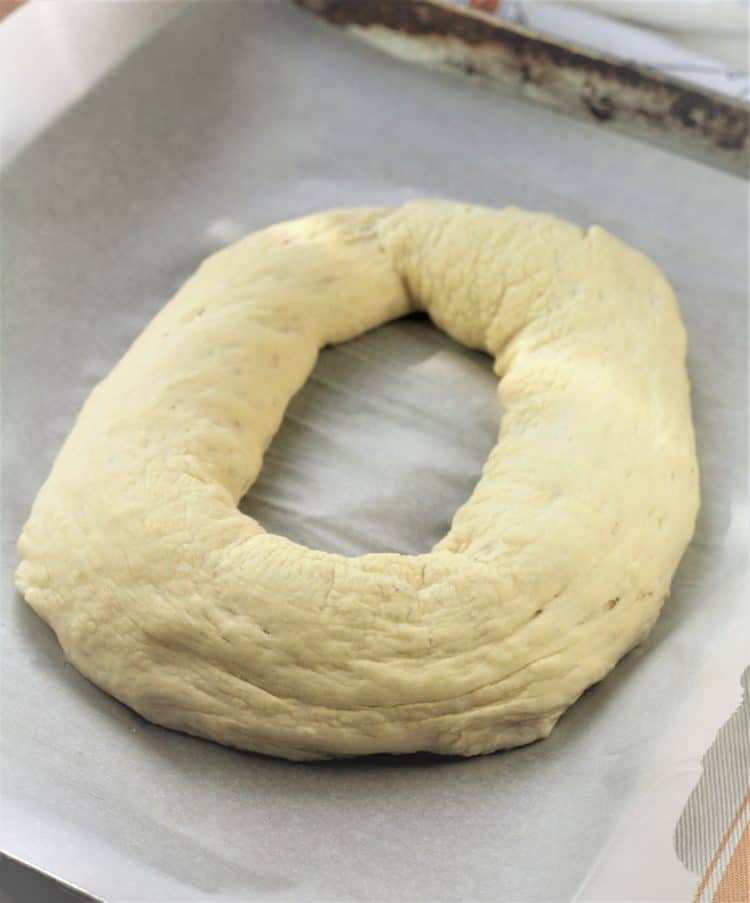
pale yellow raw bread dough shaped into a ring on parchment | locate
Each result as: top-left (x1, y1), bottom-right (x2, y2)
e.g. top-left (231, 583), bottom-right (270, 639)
top-left (17, 201), bottom-right (698, 759)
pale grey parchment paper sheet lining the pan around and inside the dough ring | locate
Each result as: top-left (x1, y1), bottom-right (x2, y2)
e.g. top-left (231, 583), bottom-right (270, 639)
top-left (0, 2), bottom-right (748, 901)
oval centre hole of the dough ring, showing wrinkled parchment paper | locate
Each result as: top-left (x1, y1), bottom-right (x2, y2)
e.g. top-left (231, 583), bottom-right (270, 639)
top-left (239, 314), bottom-right (500, 555)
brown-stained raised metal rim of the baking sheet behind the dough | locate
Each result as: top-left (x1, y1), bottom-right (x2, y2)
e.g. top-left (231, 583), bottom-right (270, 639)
top-left (296, 0), bottom-right (750, 176)
